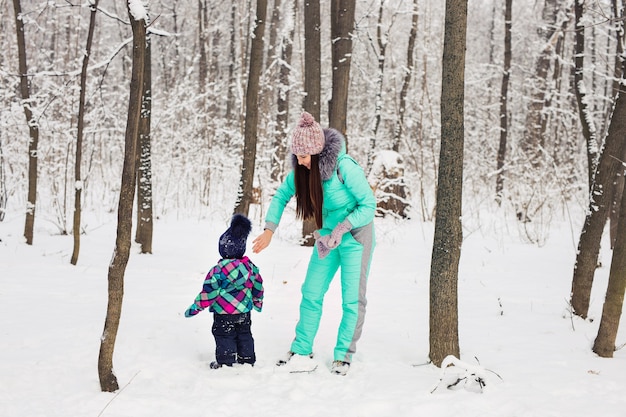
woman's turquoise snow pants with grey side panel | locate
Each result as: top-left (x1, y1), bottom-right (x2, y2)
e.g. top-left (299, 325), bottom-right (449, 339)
top-left (291, 222), bottom-right (375, 362)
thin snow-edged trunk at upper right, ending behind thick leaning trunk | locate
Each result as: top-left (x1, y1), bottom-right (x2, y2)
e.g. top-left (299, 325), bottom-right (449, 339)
top-left (574, 0), bottom-right (598, 190)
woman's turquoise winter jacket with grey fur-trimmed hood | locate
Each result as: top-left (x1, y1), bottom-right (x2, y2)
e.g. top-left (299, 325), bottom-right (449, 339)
top-left (265, 129), bottom-right (376, 235)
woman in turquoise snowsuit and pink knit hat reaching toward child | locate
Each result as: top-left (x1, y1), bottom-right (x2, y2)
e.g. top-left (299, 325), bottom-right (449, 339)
top-left (253, 112), bottom-right (376, 375)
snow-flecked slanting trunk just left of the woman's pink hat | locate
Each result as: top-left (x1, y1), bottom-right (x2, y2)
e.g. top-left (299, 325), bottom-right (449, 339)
top-left (271, 0), bottom-right (297, 182)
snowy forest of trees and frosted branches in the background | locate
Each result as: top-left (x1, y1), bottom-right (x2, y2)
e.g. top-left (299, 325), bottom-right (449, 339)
top-left (0, 0), bottom-right (626, 396)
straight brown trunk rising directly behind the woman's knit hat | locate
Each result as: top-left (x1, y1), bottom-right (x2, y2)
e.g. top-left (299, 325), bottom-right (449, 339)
top-left (302, 0), bottom-right (322, 246)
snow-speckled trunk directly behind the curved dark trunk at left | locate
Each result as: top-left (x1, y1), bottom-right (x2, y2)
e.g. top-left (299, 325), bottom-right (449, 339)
top-left (135, 35), bottom-right (154, 253)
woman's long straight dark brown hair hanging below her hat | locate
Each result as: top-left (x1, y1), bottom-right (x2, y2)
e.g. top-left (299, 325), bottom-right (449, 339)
top-left (294, 155), bottom-right (324, 229)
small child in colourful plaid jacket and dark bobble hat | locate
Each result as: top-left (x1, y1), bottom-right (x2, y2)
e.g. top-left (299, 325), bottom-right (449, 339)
top-left (185, 214), bottom-right (263, 369)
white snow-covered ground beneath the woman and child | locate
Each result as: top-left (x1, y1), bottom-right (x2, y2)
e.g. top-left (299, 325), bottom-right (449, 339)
top-left (0, 208), bottom-right (626, 417)
